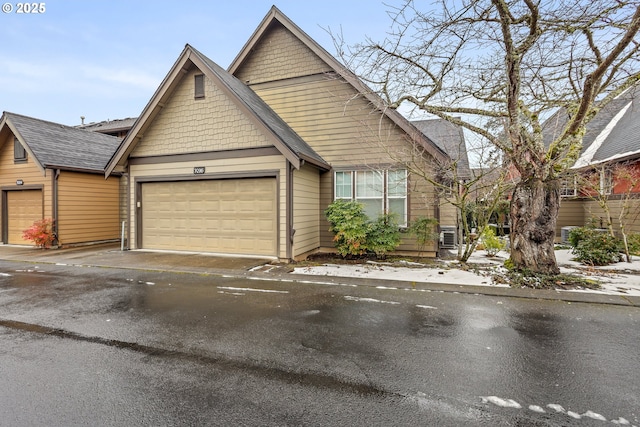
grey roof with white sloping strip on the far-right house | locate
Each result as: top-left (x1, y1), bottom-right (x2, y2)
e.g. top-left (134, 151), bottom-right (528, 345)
top-left (543, 87), bottom-right (640, 169)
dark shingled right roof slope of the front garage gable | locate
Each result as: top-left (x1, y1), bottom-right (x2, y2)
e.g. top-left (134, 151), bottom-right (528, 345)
top-left (191, 47), bottom-right (330, 169)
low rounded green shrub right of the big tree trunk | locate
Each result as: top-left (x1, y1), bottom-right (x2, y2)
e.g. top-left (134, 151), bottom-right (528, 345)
top-left (569, 227), bottom-right (622, 265)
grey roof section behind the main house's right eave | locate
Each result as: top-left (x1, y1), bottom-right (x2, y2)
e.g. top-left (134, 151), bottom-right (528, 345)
top-left (411, 119), bottom-right (471, 179)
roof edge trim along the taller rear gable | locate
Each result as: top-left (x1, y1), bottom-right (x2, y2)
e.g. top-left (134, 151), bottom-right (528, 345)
top-left (228, 6), bottom-right (449, 166)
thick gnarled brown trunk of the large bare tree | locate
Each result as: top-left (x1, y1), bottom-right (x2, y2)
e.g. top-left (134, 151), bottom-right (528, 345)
top-left (510, 178), bottom-right (560, 274)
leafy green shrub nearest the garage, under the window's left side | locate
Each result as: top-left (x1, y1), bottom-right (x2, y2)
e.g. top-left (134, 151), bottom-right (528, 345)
top-left (324, 199), bottom-right (368, 257)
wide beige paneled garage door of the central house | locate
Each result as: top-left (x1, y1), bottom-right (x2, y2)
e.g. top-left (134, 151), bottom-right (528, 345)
top-left (139, 178), bottom-right (278, 256)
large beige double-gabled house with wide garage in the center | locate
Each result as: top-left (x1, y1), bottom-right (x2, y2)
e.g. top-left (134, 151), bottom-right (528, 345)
top-left (106, 7), bottom-right (456, 260)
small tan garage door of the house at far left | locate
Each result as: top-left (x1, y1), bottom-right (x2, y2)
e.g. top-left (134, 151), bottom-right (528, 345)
top-left (6, 190), bottom-right (43, 245)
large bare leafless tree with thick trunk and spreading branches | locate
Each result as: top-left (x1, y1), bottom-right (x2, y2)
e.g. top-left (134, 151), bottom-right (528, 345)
top-left (337, 0), bottom-right (640, 274)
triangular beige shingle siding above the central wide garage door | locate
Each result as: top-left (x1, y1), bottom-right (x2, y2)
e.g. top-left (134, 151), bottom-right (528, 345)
top-left (131, 70), bottom-right (273, 157)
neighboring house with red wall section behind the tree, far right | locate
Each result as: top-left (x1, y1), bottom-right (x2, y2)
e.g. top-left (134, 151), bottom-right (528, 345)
top-left (544, 88), bottom-right (640, 239)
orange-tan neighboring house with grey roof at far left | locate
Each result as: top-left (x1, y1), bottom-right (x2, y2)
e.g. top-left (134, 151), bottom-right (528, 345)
top-left (0, 112), bottom-right (120, 245)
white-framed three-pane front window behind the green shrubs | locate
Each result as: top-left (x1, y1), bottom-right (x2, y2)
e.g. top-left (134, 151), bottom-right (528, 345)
top-left (334, 169), bottom-right (407, 226)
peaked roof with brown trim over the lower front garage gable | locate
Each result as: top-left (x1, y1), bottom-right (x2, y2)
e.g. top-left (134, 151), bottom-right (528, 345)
top-left (105, 44), bottom-right (330, 176)
